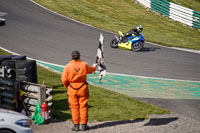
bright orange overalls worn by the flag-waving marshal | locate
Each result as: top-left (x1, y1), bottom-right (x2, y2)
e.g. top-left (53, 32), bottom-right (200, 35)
top-left (61, 60), bottom-right (96, 124)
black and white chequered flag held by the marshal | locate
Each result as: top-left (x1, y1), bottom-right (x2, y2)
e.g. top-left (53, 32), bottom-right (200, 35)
top-left (96, 33), bottom-right (106, 81)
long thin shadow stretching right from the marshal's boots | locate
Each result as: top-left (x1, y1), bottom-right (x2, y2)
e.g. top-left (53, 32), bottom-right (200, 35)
top-left (90, 119), bottom-right (145, 130)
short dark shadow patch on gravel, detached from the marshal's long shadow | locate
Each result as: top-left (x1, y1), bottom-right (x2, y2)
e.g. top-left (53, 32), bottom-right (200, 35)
top-left (144, 117), bottom-right (178, 126)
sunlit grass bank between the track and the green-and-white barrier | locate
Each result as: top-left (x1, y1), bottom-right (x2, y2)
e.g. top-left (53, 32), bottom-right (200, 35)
top-left (34, 0), bottom-right (200, 50)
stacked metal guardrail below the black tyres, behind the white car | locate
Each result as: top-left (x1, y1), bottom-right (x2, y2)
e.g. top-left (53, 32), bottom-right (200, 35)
top-left (0, 77), bottom-right (53, 118)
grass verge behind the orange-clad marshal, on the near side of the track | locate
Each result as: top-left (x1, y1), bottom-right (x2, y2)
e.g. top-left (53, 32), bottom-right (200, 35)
top-left (0, 50), bottom-right (170, 121)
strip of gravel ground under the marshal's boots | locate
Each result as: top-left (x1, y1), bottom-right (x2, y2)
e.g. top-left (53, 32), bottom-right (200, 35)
top-left (33, 113), bottom-right (200, 133)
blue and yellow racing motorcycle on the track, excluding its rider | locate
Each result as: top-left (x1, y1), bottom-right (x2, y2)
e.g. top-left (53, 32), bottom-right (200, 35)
top-left (110, 31), bottom-right (144, 52)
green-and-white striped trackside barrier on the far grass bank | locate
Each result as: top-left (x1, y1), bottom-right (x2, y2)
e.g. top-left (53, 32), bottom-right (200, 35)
top-left (137, 0), bottom-right (200, 29)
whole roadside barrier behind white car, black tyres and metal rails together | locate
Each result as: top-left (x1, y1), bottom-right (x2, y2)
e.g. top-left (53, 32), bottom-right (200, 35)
top-left (0, 55), bottom-right (53, 118)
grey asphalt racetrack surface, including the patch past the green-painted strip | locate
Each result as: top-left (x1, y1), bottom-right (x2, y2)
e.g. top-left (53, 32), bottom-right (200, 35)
top-left (0, 0), bottom-right (200, 120)
